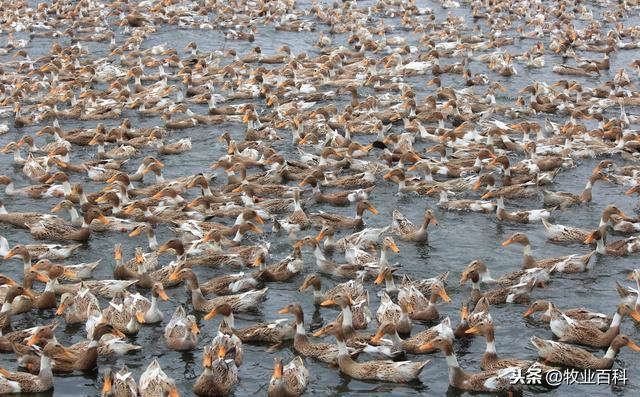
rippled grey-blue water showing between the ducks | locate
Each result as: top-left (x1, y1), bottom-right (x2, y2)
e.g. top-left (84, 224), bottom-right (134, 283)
top-left (0, 1), bottom-right (640, 396)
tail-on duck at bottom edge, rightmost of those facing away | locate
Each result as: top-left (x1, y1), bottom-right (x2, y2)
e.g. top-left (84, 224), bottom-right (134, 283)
top-left (267, 356), bottom-right (309, 397)
